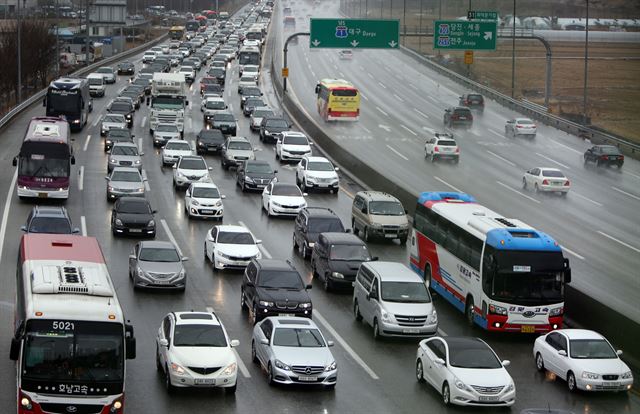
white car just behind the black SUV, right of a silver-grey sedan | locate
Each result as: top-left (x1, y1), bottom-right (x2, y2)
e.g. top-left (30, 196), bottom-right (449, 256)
top-left (204, 225), bottom-right (262, 270)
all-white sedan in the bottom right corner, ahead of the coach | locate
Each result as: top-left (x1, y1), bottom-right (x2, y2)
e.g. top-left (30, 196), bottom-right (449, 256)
top-left (533, 329), bottom-right (633, 391)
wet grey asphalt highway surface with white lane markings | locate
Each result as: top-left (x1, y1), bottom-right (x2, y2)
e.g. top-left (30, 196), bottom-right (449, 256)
top-left (0, 1), bottom-right (640, 414)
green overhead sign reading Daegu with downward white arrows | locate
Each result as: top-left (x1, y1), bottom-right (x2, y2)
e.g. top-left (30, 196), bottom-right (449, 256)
top-left (309, 18), bottom-right (400, 49)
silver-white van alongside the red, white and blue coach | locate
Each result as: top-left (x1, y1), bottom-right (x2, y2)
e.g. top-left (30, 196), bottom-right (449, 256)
top-left (353, 261), bottom-right (438, 339)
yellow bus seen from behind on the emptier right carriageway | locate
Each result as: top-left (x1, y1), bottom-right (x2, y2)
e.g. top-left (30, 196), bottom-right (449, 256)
top-left (316, 79), bottom-right (360, 121)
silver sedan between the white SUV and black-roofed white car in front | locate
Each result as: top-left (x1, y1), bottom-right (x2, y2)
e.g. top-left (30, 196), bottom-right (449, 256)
top-left (251, 316), bottom-right (338, 388)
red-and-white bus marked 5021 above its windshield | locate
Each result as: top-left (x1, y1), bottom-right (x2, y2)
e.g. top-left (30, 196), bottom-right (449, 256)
top-left (10, 234), bottom-right (136, 414)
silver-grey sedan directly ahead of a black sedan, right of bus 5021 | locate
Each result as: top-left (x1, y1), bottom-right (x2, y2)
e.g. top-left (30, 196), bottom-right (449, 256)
top-left (129, 240), bottom-right (187, 291)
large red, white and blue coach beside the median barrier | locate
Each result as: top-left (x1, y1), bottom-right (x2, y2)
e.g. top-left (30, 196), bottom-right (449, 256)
top-left (409, 192), bottom-right (571, 333)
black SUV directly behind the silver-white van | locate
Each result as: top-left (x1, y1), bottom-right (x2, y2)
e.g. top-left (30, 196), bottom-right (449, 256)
top-left (311, 233), bottom-right (377, 290)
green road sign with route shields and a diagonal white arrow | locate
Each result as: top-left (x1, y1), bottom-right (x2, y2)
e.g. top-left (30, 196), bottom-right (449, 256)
top-left (433, 20), bottom-right (497, 50)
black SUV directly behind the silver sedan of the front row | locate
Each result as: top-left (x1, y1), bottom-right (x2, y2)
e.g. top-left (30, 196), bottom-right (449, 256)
top-left (240, 259), bottom-right (312, 324)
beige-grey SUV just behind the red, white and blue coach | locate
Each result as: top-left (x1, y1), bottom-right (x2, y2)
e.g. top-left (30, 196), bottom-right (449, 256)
top-left (351, 191), bottom-right (409, 244)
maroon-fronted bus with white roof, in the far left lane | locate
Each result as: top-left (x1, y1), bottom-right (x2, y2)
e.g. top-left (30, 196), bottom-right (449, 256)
top-left (13, 117), bottom-right (76, 199)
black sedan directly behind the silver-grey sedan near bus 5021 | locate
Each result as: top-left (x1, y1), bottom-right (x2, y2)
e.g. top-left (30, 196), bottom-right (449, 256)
top-left (111, 197), bottom-right (156, 238)
